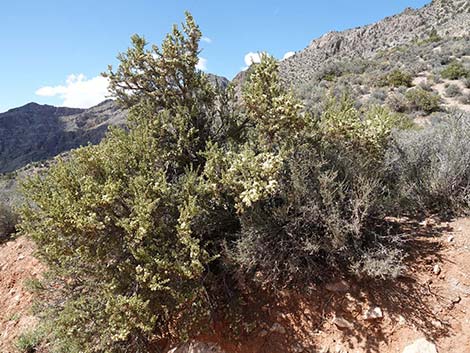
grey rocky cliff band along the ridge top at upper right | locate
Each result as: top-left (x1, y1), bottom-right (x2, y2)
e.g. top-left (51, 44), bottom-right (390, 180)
top-left (280, 0), bottom-right (470, 85)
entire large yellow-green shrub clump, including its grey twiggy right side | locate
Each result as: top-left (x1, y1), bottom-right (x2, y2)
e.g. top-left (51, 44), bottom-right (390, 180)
top-left (20, 14), bottom-right (422, 352)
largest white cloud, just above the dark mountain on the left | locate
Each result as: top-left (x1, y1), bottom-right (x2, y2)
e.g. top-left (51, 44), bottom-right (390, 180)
top-left (36, 74), bottom-right (109, 108)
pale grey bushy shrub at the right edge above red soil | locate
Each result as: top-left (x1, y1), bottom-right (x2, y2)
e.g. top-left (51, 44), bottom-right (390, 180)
top-left (388, 113), bottom-right (470, 213)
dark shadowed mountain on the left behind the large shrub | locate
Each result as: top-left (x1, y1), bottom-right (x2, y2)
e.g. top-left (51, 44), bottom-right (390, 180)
top-left (0, 100), bottom-right (126, 173)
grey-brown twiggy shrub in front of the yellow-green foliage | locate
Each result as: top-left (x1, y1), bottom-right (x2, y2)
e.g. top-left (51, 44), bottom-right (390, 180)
top-left (231, 144), bottom-right (386, 288)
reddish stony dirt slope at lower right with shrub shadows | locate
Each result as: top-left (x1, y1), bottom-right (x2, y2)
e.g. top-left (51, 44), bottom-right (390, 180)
top-left (193, 218), bottom-right (470, 353)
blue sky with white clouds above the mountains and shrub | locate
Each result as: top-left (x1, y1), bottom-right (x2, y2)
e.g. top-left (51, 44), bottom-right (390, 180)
top-left (0, 0), bottom-right (429, 112)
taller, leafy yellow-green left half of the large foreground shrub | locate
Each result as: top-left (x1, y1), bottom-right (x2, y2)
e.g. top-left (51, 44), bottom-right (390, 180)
top-left (21, 15), bottom-right (242, 352)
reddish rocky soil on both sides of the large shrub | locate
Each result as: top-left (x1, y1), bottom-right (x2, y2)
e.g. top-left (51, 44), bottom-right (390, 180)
top-left (0, 218), bottom-right (470, 353)
